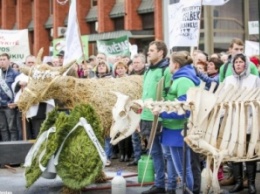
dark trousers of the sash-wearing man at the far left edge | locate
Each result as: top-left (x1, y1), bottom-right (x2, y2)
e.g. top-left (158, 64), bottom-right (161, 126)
top-left (0, 108), bottom-right (18, 141)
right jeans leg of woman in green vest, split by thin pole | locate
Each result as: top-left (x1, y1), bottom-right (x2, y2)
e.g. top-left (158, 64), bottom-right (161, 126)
top-left (170, 146), bottom-right (194, 192)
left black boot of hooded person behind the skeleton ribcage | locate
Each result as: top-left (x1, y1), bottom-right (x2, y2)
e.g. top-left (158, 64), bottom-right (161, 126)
top-left (229, 162), bottom-right (244, 193)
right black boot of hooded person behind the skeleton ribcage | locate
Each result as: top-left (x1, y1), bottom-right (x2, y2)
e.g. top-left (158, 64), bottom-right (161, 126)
top-left (246, 162), bottom-right (256, 194)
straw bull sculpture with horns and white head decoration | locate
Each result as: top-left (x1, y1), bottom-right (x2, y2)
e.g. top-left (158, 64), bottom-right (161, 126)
top-left (17, 60), bottom-right (143, 139)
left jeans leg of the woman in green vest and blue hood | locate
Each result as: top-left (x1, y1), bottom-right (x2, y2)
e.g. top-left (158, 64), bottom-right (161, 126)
top-left (162, 145), bottom-right (178, 190)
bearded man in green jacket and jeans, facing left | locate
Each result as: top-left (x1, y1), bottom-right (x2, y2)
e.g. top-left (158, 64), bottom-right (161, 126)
top-left (140, 41), bottom-right (171, 194)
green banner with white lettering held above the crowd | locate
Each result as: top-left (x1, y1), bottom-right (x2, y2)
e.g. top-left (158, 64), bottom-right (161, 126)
top-left (97, 36), bottom-right (130, 56)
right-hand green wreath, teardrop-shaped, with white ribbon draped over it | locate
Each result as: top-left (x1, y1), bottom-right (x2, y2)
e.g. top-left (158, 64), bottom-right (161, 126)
top-left (57, 105), bottom-right (104, 189)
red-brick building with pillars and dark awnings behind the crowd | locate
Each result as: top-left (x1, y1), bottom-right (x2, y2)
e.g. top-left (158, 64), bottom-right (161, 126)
top-left (0, 0), bottom-right (160, 55)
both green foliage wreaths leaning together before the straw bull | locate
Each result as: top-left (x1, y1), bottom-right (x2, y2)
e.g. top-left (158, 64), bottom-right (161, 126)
top-left (25, 104), bottom-right (104, 189)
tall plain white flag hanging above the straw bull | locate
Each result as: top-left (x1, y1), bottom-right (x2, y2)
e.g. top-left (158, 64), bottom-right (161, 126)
top-left (63, 0), bottom-right (83, 65)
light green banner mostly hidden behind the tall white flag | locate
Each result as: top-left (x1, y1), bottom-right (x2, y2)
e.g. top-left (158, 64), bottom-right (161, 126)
top-left (52, 35), bottom-right (89, 59)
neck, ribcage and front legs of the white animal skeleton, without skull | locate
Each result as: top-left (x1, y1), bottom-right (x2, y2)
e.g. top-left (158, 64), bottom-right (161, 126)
top-left (111, 84), bottom-right (260, 193)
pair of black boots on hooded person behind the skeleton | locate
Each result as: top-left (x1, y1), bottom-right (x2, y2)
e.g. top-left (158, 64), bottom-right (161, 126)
top-left (229, 161), bottom-right (256, 194)
